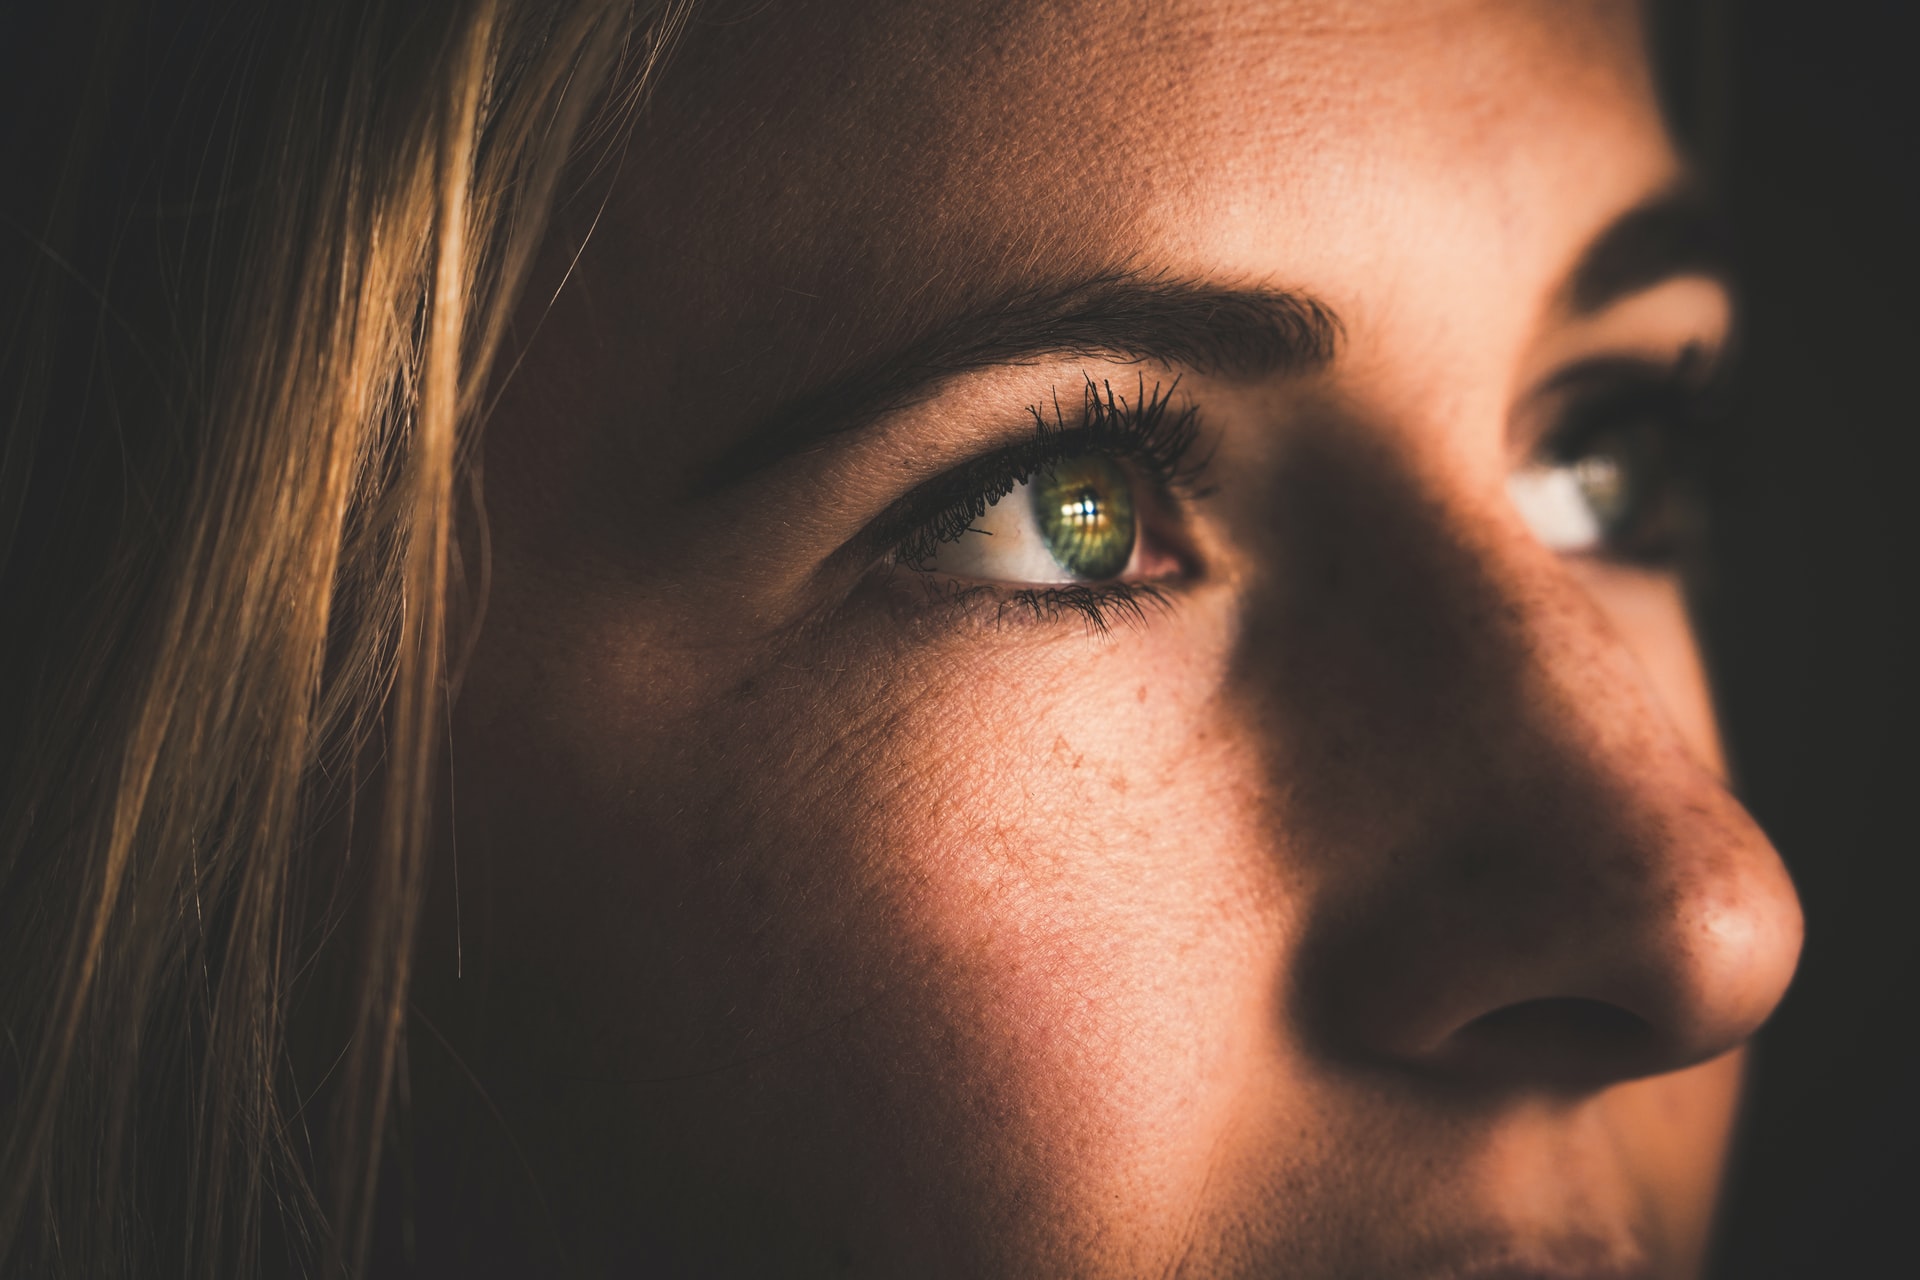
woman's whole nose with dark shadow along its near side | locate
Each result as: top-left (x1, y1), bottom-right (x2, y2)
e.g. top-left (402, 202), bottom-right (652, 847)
top-left (1248, 435), bottom-right (1801, 1088)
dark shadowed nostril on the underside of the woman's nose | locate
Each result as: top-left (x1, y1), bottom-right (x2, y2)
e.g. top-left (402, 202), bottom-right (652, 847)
top-left (1442, 996), bottom-right (1663, 1088)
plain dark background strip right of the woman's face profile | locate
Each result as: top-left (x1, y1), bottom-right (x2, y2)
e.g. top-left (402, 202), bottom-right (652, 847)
top-left (1674, 0), bottom-right (1920, 1280)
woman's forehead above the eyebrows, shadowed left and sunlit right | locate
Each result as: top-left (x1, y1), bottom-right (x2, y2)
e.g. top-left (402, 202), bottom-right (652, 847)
top-left (552, 0), bottom-right (1674, 449)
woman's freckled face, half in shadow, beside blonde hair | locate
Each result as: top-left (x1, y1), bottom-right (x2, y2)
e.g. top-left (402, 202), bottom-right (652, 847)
top-left (435, 0), bottom-right (1801, 1280)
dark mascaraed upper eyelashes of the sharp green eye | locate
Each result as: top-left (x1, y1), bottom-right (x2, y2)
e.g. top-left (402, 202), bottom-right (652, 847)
top-left (889, 374), bottom-right (1206, 568)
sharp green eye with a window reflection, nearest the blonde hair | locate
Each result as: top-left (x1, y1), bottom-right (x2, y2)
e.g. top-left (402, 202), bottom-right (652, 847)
top-left (920, 455), bottom-right (1139, 583)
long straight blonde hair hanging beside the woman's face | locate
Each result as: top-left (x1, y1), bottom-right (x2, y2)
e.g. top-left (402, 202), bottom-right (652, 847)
top-left (0, 0), bottom-right (687, 1278)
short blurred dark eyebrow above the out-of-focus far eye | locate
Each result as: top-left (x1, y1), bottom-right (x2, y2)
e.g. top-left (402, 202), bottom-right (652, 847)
top-left (1563, 184), bottom-right (1732, 317)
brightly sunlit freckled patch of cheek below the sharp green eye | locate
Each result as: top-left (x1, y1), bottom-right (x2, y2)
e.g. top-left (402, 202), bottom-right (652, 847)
top-left (787, 635), bottom-right (1279, 1257)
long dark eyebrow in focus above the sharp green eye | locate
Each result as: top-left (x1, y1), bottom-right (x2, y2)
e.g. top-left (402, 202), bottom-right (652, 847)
top-left (707, 269), bottom-right (1342, 489)
